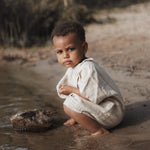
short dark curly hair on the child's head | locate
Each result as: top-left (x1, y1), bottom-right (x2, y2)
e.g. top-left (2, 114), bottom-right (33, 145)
top-left (51, 21), bottom-right (85, 42)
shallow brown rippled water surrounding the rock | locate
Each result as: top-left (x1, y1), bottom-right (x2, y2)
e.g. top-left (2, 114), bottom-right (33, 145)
top-left (0, 63), bottom-right (73, 150)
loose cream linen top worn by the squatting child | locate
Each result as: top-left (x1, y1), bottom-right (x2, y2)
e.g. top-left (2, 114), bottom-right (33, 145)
top-left (56, 58), bottom-right (123, 104)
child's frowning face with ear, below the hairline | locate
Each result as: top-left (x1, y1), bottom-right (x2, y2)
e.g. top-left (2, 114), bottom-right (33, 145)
top-left (53, 33), bottom-right (88, 68)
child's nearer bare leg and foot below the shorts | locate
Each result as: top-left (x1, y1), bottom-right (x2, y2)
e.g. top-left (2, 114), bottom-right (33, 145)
top-left (64, 105), bottom-right (109, 137)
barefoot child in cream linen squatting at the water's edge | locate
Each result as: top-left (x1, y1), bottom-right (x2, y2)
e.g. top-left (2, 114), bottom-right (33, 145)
top-left (52, 22), bottom-right (124, 137)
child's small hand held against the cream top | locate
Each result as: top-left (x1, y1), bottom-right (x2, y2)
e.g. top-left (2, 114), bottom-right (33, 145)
top-left (59, 85), bottom-right (75, 95)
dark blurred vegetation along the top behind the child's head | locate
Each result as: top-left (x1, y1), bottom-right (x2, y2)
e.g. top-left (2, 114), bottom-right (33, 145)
top-left (0, 0), bottom-right (148, 48)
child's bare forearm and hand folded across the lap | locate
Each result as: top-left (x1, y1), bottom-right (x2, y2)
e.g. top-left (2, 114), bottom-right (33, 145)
top-left (59, 85), bottom-right (89, 101)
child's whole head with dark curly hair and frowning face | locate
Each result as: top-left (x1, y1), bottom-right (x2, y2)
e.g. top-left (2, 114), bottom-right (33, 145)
top-left (52, 22), bottom-right (88, 67)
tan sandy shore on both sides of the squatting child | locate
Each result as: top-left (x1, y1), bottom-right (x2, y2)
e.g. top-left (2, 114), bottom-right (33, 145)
top-left (0, 3), bottom-right (150, 150)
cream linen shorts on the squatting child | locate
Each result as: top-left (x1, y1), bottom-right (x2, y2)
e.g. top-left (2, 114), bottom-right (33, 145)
top-left (64, 93), bottom-right (124, 129)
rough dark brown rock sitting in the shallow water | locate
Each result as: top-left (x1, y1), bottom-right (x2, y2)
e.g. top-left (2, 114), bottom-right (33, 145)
top-left (10, 110), bottom-right (53, 132)
